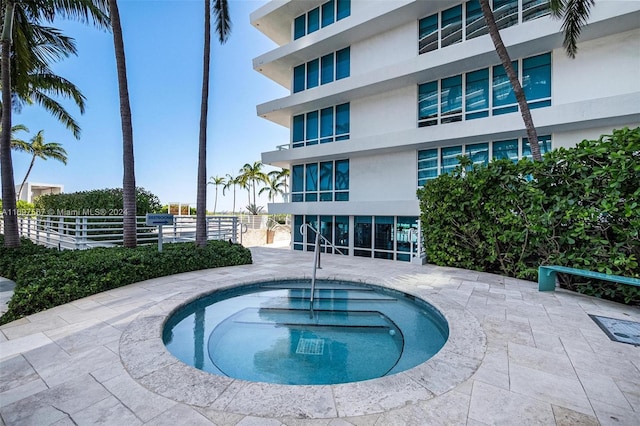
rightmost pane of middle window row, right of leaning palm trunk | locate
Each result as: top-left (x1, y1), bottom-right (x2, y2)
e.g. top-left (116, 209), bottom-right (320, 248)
top-left (522, 53), bottom-right (551, 108)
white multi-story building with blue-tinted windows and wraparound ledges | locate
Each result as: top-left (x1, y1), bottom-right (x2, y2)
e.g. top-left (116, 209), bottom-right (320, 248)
top-left (251, 0), bottom-right (640, 261)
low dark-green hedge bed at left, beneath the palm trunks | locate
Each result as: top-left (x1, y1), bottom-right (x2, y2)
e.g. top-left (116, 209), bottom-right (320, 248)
top-left (0, 236), bottom-right (252, 324)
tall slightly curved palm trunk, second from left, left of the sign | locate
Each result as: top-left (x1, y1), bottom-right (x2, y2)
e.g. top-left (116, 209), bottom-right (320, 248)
top-left (108, 0), bottom-right (137, 248)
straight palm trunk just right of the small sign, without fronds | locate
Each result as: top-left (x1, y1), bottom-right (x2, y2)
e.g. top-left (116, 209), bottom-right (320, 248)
top-left (196, 0), bottom-right (211, 247)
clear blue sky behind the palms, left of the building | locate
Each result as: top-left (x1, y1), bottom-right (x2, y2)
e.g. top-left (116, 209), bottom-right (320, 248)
top-left (13, 0), bottom-right (289, 211)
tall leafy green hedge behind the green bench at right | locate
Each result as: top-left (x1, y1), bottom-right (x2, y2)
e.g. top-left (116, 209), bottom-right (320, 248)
top-left (418, 127), bottom-right (640, 304)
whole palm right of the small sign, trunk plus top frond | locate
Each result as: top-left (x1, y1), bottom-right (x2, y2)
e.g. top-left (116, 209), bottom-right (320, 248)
top-left (196, 0), bottom-right (231, 246)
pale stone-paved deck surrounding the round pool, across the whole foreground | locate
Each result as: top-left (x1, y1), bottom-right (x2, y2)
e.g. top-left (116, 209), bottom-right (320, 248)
top-left (0, 247), bottom-right (640, 426)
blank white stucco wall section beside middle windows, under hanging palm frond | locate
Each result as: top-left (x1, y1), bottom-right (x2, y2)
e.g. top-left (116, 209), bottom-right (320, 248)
top-left (551, 29), bottom-right (640, 105)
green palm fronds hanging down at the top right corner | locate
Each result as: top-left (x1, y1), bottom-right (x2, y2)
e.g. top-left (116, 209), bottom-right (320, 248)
top-left (550, 0), bottom-right (596, 59)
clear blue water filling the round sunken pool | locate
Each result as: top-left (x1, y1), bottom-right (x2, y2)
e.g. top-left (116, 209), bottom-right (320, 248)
top-left (163, 280), bottom-right (449, 385)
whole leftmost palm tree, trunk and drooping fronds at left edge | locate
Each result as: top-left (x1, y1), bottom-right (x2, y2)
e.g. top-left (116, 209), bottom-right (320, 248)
top-left (0, 0), bottom-right (108, 248)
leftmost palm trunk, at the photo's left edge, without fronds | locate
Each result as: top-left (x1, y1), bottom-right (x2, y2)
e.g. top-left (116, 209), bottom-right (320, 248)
top-left (0, 1), bottom-right (20, 248)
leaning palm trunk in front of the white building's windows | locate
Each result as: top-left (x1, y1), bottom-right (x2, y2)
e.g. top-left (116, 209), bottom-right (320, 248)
top-left (480, 0), bottom-right (542, 161)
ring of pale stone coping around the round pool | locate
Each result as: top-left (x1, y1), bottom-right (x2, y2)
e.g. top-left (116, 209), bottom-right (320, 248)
top-left (120, 273), bottom-right (487, 419)
